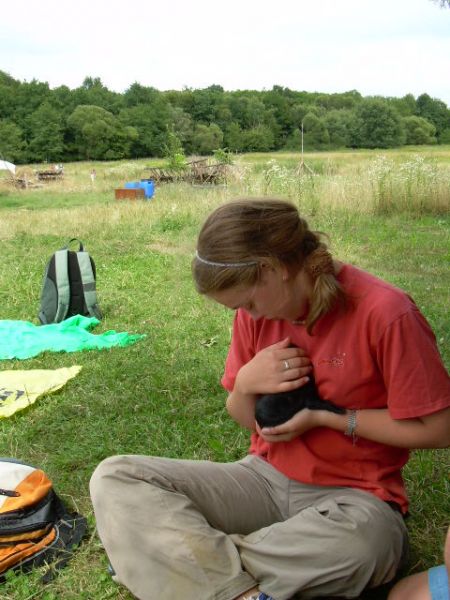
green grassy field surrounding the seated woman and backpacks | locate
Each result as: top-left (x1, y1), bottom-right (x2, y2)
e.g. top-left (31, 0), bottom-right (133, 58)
top-left (0, 147), bottom-right (450, 600)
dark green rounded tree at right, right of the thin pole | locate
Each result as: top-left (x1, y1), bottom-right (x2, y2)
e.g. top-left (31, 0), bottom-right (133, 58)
top-left (351, 98), bottom-right (405, 148)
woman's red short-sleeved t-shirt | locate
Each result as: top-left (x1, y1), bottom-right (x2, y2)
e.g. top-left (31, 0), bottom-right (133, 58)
top-left (222, 265), bottom-right (450, 512)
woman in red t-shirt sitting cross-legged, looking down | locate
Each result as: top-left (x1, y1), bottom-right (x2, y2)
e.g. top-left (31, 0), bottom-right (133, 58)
top-left (91, 199), bottom-right (450, 600)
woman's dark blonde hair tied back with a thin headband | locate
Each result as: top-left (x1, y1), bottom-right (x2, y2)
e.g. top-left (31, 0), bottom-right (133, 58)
top-left (192, 198), bottom-right (346, 334)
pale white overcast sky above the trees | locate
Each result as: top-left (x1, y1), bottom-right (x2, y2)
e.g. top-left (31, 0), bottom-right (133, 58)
top-left (0, 0), bottom-right (450, 106)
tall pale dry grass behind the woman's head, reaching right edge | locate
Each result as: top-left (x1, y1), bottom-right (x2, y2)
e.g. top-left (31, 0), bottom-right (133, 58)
top-left (249, 154), bottom-right (450, 215)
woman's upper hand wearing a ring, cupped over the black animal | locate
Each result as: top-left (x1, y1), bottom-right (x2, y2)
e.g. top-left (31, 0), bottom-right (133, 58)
top-left (234, 337), bottom-right (312, 395)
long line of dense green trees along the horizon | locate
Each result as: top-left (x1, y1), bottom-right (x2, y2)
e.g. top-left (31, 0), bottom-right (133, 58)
top-left (0, 71), bottom-right (450, 164)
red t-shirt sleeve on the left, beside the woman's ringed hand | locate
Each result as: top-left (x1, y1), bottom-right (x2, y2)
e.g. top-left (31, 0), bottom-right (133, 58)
top-left (221, 310), bottom-right (255, 392)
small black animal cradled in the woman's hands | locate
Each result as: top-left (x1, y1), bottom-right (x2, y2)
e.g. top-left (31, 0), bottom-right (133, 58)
top-left (255, 375), bottom-right (345, 427)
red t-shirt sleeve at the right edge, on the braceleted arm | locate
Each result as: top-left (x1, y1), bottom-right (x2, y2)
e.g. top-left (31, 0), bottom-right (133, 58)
top-left (377, 306), bottom-right (450, 419)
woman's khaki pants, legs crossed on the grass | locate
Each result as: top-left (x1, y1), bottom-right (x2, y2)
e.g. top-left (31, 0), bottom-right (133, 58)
top-left (91, 456), bottom-right (407, 600)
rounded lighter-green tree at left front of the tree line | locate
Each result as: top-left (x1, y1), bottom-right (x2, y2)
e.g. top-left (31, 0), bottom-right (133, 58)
top-left (67, 105), bottom-right (138, 160)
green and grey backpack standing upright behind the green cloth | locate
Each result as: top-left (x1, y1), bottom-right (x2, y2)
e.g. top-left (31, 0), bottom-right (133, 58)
top-left (38, 238), bottom-right (102, 324)
